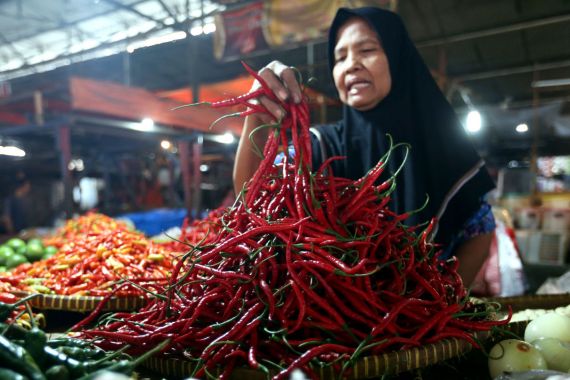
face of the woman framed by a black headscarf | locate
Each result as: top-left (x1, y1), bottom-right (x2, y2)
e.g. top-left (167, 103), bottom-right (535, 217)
top-left (333, 17), bottom-right (392, 111)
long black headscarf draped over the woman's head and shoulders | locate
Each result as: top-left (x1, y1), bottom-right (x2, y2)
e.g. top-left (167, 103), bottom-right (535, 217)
top-left (313, 7), bottom-right (494, 249)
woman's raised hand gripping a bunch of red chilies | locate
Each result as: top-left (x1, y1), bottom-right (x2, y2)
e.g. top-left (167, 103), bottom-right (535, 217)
top-left (250, 61), bottom-right (302, 122)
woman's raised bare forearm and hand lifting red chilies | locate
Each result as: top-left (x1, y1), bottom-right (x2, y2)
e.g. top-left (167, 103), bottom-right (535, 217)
top-left (233, 61), bottom-right (302, 194)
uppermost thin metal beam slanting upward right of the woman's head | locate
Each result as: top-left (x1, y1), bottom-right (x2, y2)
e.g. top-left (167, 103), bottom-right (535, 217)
top-left (415, 14), bottom-right (570, 49)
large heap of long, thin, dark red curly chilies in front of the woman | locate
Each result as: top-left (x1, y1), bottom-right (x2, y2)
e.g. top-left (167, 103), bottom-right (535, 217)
top-left (77, 63), bottom-right (508, 379)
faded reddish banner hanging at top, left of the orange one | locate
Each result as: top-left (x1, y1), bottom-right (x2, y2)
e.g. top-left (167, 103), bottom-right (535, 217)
top-left (214, 1), bottom-right (268, 59)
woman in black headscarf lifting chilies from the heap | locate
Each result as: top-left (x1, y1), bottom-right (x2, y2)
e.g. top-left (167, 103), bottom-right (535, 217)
top-left (234, 8), bottom-right (494, 285)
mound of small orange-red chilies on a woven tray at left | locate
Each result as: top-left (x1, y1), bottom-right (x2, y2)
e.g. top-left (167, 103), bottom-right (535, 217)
top-left (0, 214), bottom-right (175, 296)
